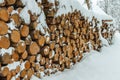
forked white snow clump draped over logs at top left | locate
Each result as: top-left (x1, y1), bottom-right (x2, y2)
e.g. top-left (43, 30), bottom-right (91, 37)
top-left (20, 0), bottom-right (41, 24)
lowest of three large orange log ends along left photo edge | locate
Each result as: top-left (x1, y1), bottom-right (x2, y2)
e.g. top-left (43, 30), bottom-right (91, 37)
top-left (0, 36), bottom-right (10, 49)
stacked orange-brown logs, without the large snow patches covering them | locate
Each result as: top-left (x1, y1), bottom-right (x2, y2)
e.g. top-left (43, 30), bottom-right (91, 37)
top-left (0, 0), bottom-right (113, 80)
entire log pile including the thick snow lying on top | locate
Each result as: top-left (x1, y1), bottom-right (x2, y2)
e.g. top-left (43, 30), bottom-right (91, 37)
top-left (0, 0), bottom-right (115, 80)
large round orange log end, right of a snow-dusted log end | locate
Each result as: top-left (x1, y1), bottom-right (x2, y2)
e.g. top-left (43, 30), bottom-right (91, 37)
top-left (29, 42), bottom-right (40, 55)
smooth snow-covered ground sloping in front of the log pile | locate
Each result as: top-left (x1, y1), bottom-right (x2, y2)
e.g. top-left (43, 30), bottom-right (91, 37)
top-left (31, 32), bottom-right (120, 80)
